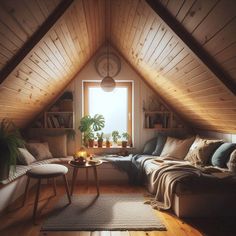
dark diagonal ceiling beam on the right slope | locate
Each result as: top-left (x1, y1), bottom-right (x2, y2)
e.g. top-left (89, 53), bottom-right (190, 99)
top-left (146, 0), bottom-right (236, 94)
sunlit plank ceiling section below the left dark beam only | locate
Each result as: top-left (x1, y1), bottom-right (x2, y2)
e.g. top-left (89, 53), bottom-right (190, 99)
top-left (0, 0), bottom-right (105, 127)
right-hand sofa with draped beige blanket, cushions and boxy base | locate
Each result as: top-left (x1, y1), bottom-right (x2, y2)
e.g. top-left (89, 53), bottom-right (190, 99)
top-left (135, 137), bottom-right (236, 217)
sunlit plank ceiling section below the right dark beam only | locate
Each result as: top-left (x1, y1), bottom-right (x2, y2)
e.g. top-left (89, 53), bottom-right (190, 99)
top-left (111, 1), bottom-right (236, 133)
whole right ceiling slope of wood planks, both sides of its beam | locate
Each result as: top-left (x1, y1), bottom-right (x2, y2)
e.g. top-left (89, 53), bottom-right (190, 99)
top-left (111, 0), bottom-right (236, 133)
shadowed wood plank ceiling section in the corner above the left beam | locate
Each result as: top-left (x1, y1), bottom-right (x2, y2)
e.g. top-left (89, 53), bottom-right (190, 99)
top-left (0, 0), bottom-right (61, 69)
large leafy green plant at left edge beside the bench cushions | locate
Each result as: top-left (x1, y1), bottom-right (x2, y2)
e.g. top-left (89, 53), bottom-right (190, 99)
top-left (0, 119), bottom-right (24, 180)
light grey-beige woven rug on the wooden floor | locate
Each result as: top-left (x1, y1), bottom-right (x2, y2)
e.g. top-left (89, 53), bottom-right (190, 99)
top-left (41, 194), bottom-right (166, 231)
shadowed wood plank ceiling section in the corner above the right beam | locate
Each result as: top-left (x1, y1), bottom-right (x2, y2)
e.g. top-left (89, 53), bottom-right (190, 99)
top-left (156, 0), bottom-right (236, 83)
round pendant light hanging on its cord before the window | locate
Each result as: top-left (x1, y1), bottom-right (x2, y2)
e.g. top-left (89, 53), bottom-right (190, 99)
top-left (100, 0), bottom-right (116, 92)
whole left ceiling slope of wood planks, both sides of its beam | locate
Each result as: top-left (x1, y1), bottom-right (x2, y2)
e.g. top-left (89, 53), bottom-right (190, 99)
top-left (0, 0), bottom-right (105, 127)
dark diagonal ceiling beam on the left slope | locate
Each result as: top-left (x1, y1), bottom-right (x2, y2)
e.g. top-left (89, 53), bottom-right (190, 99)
top-left (0, 0), bottom-right (73, 83)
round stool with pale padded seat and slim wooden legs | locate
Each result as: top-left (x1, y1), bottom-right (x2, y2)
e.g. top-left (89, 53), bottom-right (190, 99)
top-left (23, 164), bottom-right (71, 223)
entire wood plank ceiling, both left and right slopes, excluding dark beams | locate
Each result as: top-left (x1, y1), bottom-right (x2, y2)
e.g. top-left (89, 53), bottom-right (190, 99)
top-left (0, 0), bottom-right (236, 133)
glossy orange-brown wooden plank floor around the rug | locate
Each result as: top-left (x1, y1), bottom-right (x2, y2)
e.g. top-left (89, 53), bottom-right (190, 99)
top-left (0, 185), bottom-right (236, 236)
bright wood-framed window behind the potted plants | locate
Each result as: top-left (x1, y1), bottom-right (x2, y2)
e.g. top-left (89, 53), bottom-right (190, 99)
top-left (84, 82), bottom-right (132, 139)
